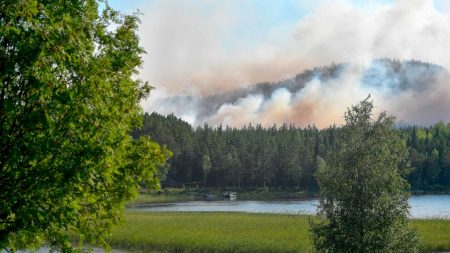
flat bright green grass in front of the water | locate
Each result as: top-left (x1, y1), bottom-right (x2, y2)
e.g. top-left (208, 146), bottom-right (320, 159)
top-left (108, 212), bottom-right (450, 252)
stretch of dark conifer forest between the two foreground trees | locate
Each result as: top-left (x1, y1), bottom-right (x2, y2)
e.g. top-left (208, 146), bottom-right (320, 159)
top-left (133, 113), bottom-right (328, 191)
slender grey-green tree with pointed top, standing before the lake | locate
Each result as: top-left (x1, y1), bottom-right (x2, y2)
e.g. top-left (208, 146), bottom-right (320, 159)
top-left (311, 97), bottom-right (417, 253)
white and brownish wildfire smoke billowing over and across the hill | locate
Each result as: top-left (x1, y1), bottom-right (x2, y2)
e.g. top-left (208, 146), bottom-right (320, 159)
top-left (141, 0), bottom-right (450, 127)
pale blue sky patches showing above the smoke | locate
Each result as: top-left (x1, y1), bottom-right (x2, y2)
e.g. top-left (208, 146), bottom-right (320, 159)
top-left (109, 0), bottom-right (450, 53)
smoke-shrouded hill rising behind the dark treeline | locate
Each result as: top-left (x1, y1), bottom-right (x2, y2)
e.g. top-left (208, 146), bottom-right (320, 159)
top-left (146, 59), bottom-right (450, 128)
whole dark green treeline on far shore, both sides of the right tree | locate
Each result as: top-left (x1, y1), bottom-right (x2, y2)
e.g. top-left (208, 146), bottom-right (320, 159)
top-left (132, 113), bottom-right (450, 192)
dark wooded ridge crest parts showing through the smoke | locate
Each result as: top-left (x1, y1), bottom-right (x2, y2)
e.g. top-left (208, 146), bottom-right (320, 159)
top-left (194, 58), bottom-right (448, 116)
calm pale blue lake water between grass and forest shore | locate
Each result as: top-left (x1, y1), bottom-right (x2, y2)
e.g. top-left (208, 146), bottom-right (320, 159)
top-left (130, 195), bottom-right (450, 218)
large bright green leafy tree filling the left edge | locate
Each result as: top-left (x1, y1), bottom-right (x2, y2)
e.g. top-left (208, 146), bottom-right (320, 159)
top-left (0, 0), bottom-right (169, 251)
